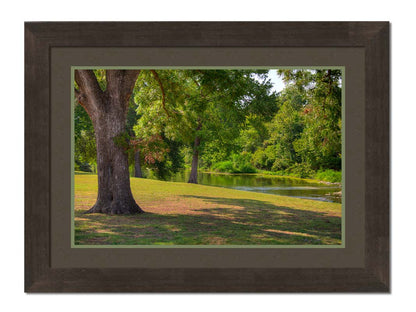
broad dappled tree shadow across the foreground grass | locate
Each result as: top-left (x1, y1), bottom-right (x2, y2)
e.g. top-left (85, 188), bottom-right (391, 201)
top-left (75, 195), bottom-right (341, 245)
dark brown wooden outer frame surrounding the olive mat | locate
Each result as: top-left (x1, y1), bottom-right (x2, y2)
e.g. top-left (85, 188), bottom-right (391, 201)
top-left (25, 22), bottom-right (390, 293)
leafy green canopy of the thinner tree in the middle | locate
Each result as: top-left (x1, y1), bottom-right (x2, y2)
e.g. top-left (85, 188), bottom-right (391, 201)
top-left (134, 70), bottom-right (276, 171)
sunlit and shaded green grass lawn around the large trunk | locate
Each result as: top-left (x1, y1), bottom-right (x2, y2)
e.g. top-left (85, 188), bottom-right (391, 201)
top-left (74, 174), bottom-right (341, 245)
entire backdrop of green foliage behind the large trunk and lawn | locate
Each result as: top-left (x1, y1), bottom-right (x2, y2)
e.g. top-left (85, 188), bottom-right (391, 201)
top-left (75, 69), bottom-right (342, 182)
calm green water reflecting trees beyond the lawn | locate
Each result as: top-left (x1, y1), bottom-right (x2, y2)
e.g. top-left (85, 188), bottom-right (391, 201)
top-left (171, 171), bottom-right (341, 203)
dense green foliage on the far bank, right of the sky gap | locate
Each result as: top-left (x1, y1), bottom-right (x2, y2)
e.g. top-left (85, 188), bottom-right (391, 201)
top-left (242, 70), bottom-right (342, 182)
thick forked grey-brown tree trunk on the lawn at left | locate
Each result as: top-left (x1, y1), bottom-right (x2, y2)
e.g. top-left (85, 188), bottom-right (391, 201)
top-left (75, 70), bottom-right (143, 214)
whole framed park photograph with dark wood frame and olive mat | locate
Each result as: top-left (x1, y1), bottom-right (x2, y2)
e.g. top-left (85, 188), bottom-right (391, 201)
top-left (25, 22), bottom-right (390, 292)
